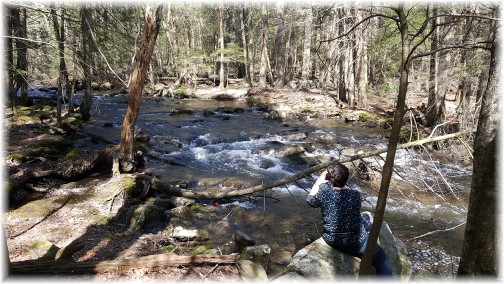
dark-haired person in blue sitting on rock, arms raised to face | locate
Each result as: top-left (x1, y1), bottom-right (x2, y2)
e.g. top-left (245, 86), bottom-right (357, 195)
top-left (306, 162), bottom-right (392, 276)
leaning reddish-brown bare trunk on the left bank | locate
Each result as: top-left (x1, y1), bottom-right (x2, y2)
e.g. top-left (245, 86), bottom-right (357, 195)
top-left (113, 5), bottom-right (163, 174)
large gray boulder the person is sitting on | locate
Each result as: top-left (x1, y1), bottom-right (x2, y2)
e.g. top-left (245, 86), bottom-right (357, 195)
top-left (274, 219), bottom-right (411, 282)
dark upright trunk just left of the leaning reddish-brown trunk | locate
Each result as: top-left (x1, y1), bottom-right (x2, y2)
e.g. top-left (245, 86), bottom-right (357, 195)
top-left (79, 3), bottom-right (92, 120)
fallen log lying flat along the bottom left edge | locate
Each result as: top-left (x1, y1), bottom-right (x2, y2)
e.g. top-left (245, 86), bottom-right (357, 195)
top-left (9, 253), bottom-right (240, 275)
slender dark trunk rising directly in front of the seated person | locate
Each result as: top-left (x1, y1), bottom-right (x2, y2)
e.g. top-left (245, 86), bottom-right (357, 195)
top-left (359, 3), bottom-right (411, 277)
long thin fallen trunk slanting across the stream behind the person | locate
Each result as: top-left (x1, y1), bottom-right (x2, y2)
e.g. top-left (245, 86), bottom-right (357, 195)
top-left (152, 131), bottom-right (468, 199)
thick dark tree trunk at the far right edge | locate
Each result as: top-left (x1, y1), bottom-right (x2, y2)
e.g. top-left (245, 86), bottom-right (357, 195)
top-left (457, 8), bottom-right (502, 277)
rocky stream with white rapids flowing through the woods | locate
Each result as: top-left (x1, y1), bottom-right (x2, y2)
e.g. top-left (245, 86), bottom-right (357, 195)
top-left (73, 92), bottom-right (472, 278)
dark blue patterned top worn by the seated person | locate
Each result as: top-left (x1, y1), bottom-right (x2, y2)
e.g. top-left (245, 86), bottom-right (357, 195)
top-left (306, 183), bottom-right (368, 255)
